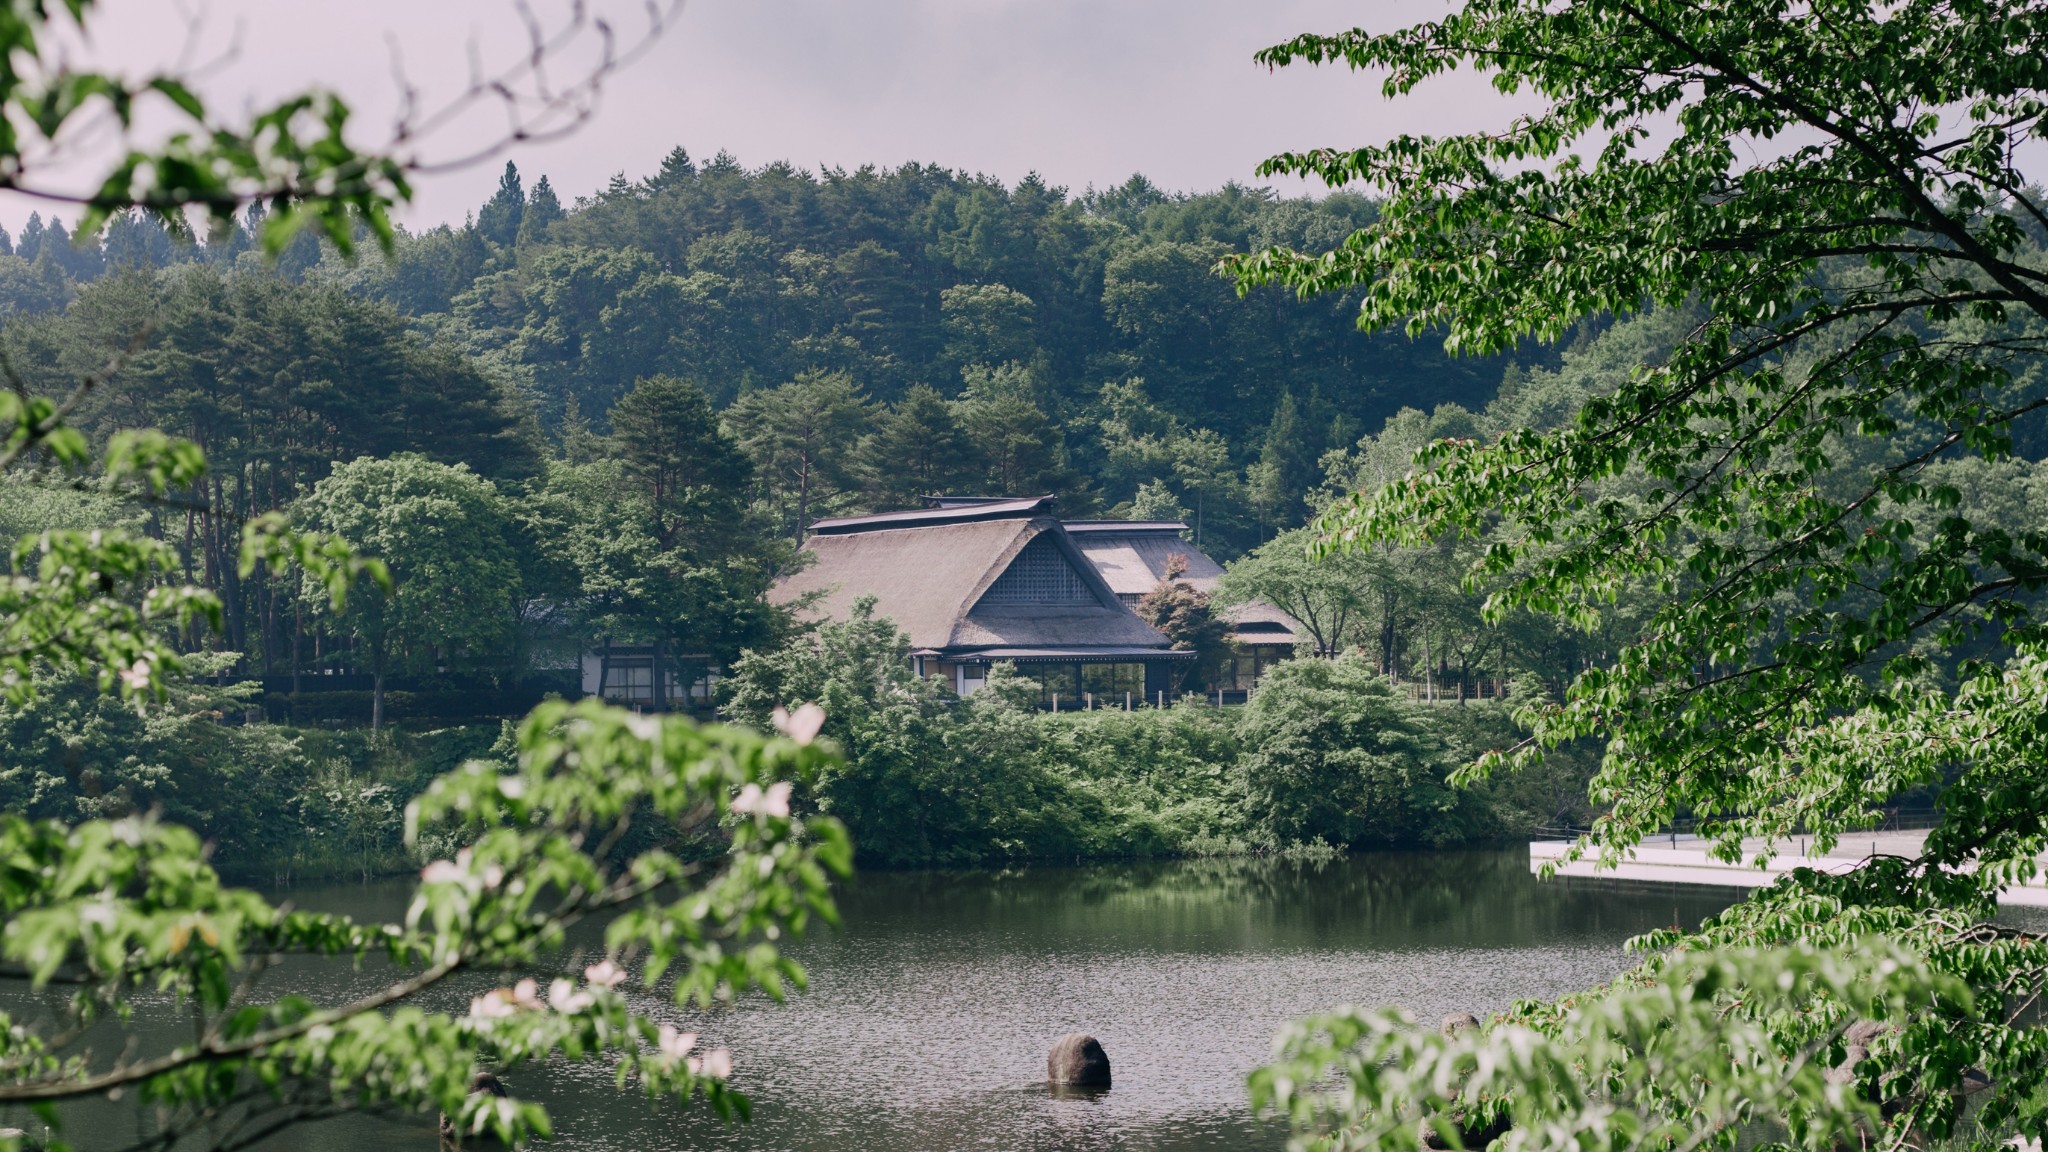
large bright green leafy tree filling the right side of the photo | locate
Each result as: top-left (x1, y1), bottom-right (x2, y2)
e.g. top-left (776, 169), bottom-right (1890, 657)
top-left (1233, 0), bottom-right (2048, 1148)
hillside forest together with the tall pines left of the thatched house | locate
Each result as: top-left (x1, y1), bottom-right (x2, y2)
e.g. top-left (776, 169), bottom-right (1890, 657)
top-left (0, 148), bottom-right (1540, 701)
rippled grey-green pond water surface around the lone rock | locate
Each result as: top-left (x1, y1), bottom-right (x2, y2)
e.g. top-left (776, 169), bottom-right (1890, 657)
top-left (39, 849), bottom-right (1735, 1152)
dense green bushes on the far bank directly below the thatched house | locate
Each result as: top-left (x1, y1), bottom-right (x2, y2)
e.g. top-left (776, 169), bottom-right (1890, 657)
top-left (727, 605), bottom-right (1585, 867)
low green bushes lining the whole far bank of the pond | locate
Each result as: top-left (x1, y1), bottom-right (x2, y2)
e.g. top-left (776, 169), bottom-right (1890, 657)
top-left (0, 607), bottom-right (1585, 879)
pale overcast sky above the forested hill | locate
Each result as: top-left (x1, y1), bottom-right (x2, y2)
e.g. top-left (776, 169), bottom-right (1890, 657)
top-left (0, 0), bottom-right (1501, 230)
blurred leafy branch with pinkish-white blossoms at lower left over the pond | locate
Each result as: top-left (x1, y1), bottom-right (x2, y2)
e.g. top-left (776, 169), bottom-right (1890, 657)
top-left (0, 703), bottom-right (850, 1148)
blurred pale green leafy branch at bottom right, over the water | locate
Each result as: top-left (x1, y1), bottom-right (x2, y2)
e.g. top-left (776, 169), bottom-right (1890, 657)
top-left (1251, 941), bottom-right (1974, 1152)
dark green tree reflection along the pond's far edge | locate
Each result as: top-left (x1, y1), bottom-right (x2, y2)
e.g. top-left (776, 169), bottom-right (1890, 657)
top-left (846, 849), bottom-right (1726, 947)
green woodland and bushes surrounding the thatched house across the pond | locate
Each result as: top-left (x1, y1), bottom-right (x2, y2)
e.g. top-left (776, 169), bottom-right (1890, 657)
top-left (0, 148), bottom-right (1591, 875)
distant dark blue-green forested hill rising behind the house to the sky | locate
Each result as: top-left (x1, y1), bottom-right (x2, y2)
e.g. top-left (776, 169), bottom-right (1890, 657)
top-left (0, 150), bottom-right (1531, 532)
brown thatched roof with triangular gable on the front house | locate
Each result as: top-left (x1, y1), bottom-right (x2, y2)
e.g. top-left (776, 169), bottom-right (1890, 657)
top-left (772, 500), bottom-right (1167, 660)
